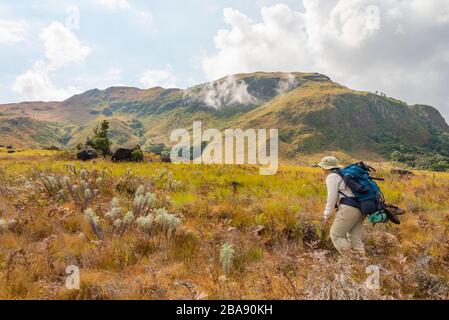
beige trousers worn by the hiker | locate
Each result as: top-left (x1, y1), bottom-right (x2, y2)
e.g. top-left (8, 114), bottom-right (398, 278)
top-left (330, 205), bottom-right (366, 254)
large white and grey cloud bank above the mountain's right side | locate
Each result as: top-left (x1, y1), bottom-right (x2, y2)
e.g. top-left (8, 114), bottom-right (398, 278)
top-left (202, 0), bottom-right (449, 115)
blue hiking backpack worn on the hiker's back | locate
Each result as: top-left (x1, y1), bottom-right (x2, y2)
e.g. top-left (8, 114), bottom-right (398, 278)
top-left (336, 162), bottom-right (388, 223)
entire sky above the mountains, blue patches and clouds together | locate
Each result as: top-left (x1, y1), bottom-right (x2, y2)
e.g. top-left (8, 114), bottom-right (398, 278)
top-left (0, 0), bottom-right (449, 120)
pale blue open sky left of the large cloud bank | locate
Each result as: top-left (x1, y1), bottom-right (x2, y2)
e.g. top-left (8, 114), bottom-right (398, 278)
top-left (0, 0), bottom-right (298, 103)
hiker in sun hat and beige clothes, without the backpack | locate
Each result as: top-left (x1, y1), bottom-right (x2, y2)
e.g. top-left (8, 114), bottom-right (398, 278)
top-left (318, 157), bottom-right (366, 256)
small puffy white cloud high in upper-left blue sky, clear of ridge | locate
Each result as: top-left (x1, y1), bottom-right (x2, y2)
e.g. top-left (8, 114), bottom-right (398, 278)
top-left (39, 22), bottom-right (91, 68)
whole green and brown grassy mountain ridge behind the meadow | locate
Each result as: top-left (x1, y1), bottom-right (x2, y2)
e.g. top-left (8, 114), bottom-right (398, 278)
top-left (0, 72), bottom-right (449, 171)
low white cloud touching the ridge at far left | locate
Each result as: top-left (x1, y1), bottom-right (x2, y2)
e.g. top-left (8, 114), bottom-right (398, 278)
top-left (12, 62), bottom-right (80, 101)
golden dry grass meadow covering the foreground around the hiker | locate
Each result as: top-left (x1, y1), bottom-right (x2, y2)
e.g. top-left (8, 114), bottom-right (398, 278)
top-left (0, 151), bottom-right (449, 299)
